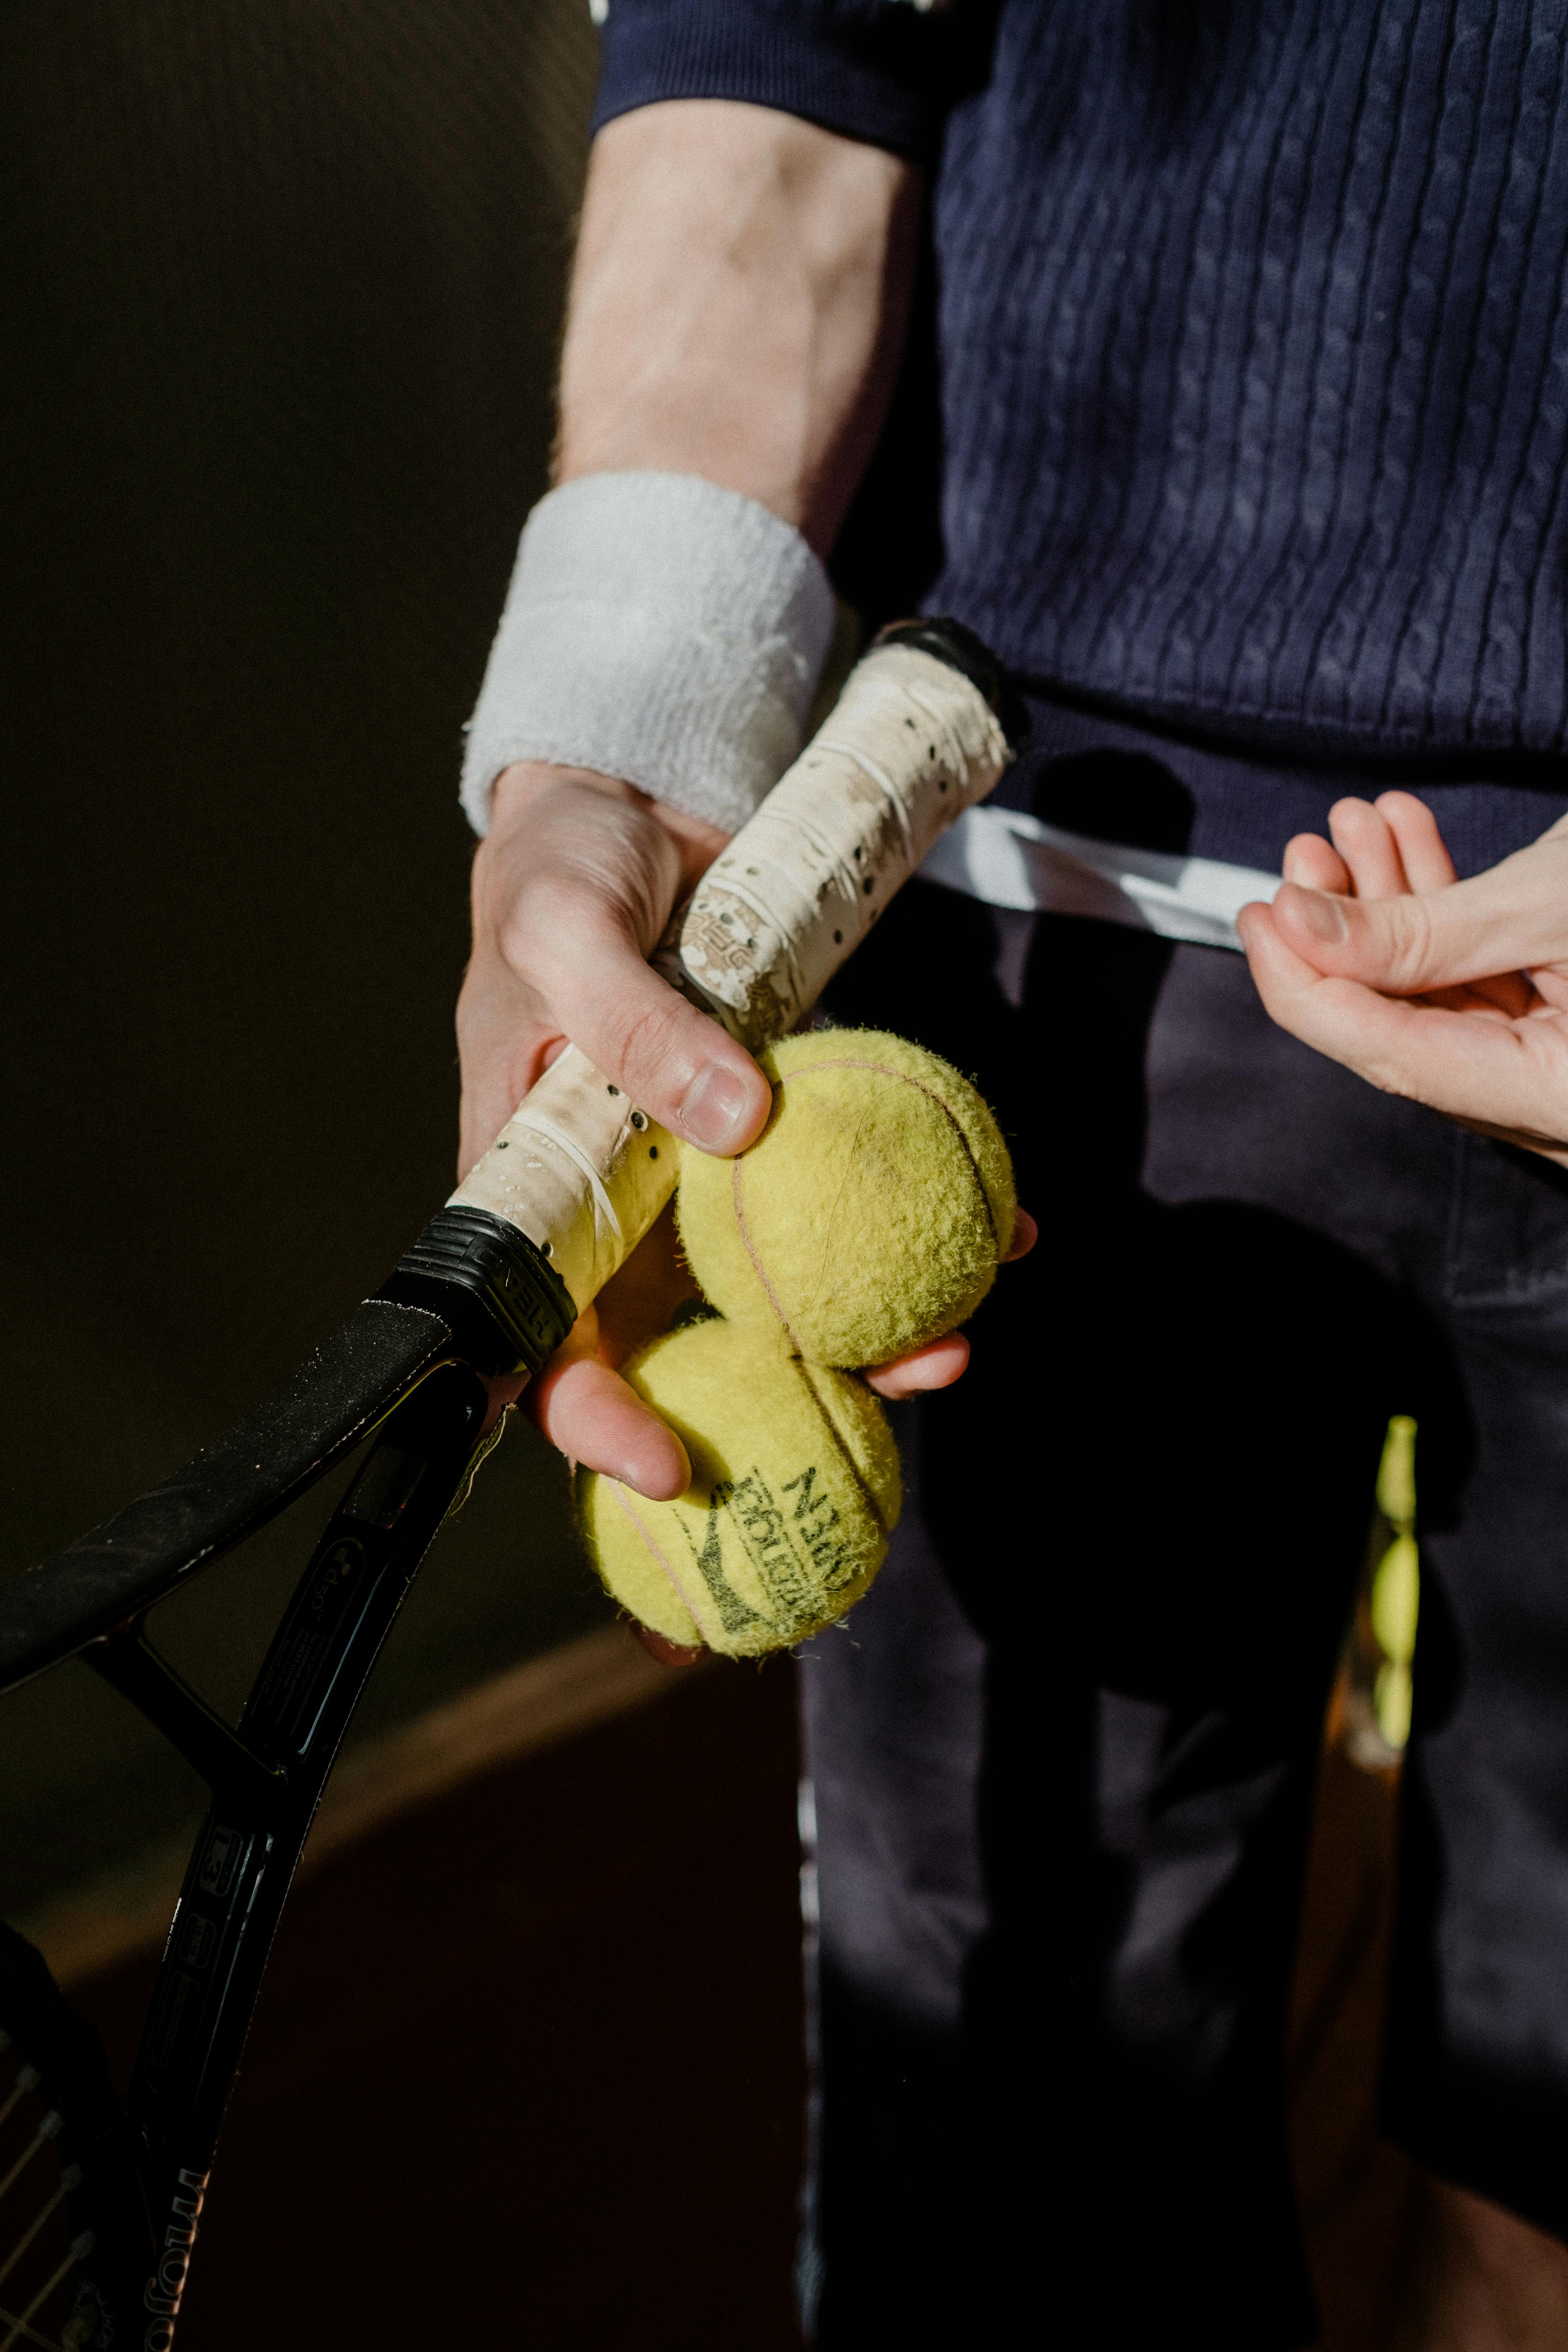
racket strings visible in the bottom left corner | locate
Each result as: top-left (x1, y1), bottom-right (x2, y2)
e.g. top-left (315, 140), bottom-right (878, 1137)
top-left (0, 2032), bottom-right (99, 2352)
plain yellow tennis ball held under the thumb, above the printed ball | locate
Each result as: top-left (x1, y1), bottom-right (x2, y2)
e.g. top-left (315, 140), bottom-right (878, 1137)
top-left (677, 1030), bottom-right (1018, 1366)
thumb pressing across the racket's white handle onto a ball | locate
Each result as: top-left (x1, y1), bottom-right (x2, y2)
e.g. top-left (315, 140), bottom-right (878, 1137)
top-left (533, 924), bottom-right (773, 1155)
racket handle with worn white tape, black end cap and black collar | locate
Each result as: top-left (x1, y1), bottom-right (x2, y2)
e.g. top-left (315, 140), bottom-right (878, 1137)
top-left (381, 621), bottom-right (1015, 1371)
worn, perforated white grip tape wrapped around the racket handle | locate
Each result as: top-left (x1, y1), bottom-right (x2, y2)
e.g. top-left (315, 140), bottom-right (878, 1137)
top-left (451, 645), bottom-right (1011, 1312)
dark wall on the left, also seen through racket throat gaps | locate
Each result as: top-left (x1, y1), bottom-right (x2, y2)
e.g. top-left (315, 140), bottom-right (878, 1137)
top-left (0, 0), bottom-right (602, 1912)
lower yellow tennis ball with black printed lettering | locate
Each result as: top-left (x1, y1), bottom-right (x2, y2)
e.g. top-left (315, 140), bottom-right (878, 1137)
top-left (578, 1317), bottom-right (900, 1658)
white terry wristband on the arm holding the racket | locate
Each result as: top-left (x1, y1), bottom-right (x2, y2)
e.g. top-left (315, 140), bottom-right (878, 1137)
top-left (463, 473), bottom-right (837, 833)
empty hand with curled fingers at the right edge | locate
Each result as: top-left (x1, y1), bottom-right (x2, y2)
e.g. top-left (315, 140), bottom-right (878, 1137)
top-left (1239, 793), bottom-right (1568, 1167)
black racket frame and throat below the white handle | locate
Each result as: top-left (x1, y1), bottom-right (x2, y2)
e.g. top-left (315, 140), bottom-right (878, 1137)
top-left (0, 1209), bottom-right (571, 2352)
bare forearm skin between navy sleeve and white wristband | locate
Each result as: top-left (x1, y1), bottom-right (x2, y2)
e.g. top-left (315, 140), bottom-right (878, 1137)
top-left (557, 99), bottom-right (922, 555)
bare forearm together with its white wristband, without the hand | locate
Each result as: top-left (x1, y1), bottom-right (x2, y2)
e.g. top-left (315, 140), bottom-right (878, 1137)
top-left (463, 99), bottom-right (919, 856)
